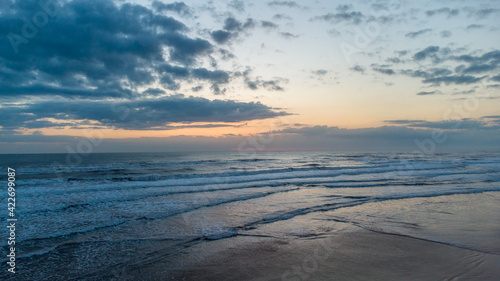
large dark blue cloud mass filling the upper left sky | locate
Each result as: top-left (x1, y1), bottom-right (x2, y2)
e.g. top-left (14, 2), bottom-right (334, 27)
top-left (0, 0), bottom-right (229, 99)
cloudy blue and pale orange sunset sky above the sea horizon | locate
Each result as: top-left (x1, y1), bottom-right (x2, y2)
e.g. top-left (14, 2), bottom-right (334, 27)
top-left (0, 0), bottom-right (500, 154)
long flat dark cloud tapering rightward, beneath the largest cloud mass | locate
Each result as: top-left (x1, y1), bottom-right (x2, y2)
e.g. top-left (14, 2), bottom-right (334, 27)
top-left (0, 95), bottom-right (288, 130)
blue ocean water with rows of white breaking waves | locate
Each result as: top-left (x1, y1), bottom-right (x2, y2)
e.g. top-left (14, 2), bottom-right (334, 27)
top-left (0, 152), bottom-right (500, 280)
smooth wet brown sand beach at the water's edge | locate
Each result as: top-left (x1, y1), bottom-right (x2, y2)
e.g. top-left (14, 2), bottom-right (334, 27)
top-left (121, 223), bottom-right (500, 281)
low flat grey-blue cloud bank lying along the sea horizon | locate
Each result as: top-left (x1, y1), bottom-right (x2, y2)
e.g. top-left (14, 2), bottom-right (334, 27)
top-left (5, 124), bottom-right (500, 153)
